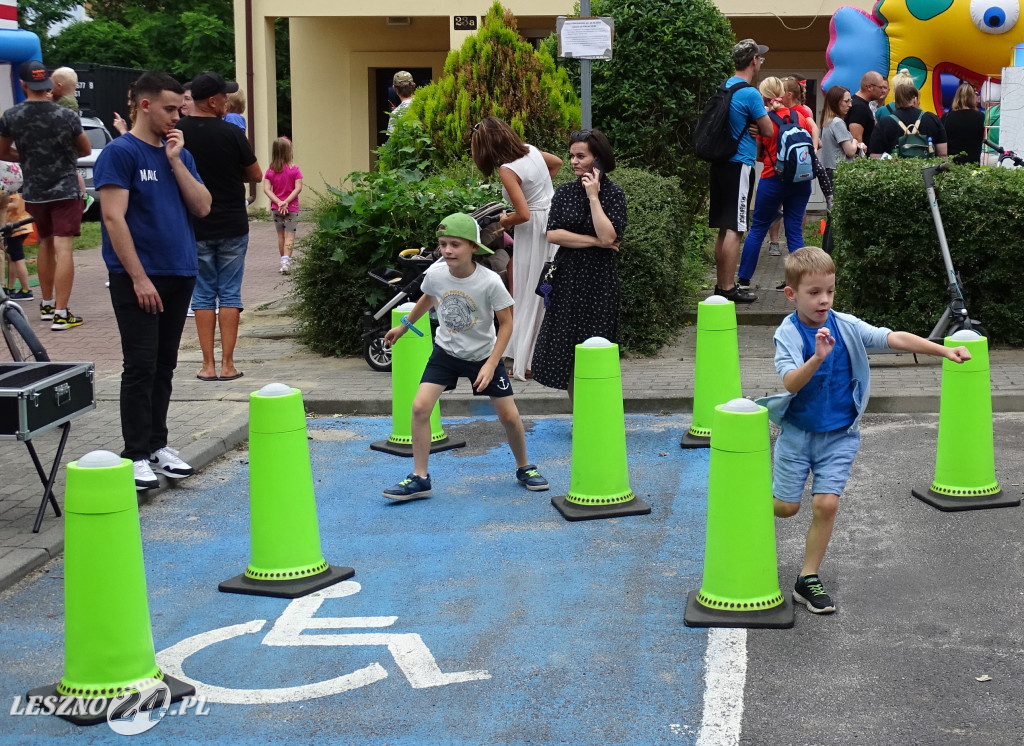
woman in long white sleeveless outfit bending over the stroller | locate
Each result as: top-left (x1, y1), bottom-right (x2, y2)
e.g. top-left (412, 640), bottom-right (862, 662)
top-left (472, 117), bottom-right (562, 381)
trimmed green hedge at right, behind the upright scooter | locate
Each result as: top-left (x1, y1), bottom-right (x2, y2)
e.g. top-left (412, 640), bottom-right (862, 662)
top-left (833, 160), bottom-right (1024, 346)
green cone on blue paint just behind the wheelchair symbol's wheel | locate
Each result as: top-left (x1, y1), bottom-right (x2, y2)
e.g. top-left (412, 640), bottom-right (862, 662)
top-left (218, 384), bottom-right (355, 599)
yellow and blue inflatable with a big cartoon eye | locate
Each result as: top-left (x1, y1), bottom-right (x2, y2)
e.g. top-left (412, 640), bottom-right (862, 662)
top-left (822, 0), bottom-right (1024, 113)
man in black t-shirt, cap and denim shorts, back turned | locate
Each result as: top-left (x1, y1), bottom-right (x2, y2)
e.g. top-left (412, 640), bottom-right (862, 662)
top-left (178, 72), bottom-right (263, 381)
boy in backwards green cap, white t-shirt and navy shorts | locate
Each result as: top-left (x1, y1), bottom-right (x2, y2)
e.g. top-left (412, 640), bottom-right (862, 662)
top-left (384, 213), bottom-right (548, 501)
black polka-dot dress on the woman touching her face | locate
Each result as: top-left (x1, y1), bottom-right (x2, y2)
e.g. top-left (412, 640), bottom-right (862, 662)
top-left (532, 176), bottom-right (626, 389)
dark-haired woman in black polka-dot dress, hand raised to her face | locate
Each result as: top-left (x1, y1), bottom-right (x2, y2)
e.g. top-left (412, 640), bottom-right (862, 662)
top-left (532, 130), bottom-right (626, 399)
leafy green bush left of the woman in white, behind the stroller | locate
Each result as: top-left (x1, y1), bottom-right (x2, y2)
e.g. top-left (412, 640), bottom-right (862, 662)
top-left (293, 169), bottom-right (498, 355)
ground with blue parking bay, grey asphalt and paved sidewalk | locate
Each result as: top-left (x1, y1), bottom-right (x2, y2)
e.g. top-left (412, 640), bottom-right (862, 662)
top-left (0, 223), bottom-right (1024, 744)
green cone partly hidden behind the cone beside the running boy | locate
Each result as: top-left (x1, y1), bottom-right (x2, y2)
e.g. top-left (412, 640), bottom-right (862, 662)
top-left (679, 296), bottom-right (742, 448)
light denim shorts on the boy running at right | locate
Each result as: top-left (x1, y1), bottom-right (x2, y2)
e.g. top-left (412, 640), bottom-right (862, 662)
top-left (772, 421), bottom-right (860, 502)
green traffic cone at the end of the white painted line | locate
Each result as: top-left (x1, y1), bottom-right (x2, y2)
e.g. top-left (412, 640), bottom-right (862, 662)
top-left (683, 399), bottom-right (795, 629)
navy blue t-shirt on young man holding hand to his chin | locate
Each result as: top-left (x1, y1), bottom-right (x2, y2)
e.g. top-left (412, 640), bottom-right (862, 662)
top-left (92, 133), bottom-right (199, 277)
